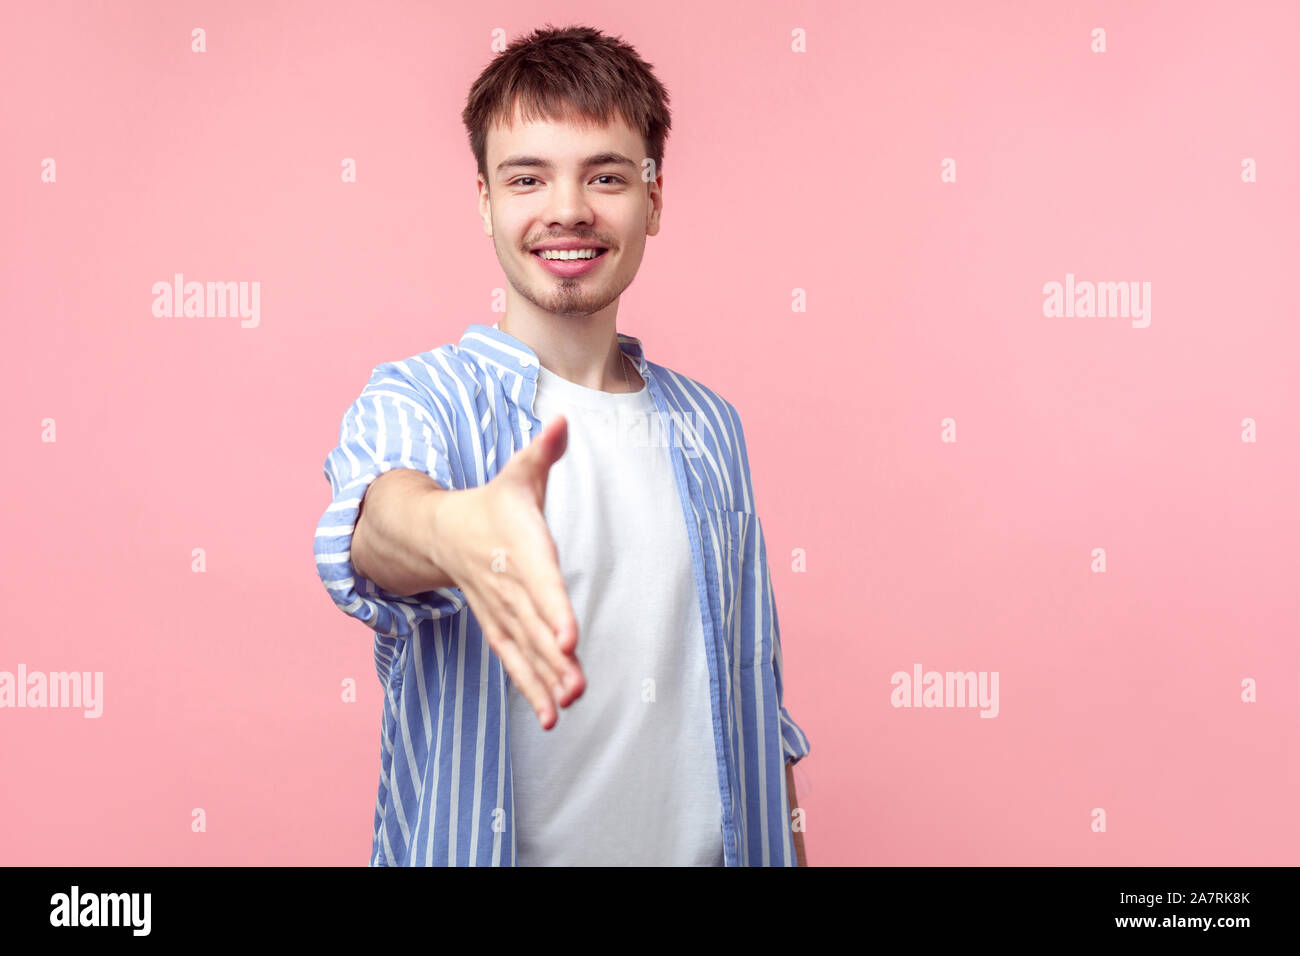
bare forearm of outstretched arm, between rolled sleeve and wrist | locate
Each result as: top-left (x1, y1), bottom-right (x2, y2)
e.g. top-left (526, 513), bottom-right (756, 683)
top-left (352, 468), bottom-right (463, 597)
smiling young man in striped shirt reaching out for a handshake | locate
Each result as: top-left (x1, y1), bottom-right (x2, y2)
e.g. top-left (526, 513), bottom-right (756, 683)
top-left (316, 27), bottom-right (810, 866)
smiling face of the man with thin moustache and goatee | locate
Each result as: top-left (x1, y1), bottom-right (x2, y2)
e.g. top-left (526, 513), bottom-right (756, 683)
top-left (478, 109), bottom-right (663, 316)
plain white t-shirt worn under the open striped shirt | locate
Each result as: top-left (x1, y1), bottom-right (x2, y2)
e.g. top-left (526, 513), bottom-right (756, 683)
top-left (510, 358), bottom-right (724, 866)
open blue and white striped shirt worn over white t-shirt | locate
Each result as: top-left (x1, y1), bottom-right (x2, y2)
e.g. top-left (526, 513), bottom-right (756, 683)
top-left (315, 323), bottom-right (809, 866)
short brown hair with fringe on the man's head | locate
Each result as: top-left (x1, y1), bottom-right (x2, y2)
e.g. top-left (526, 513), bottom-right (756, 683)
top-left (460, 23), bottom-right (672, 183)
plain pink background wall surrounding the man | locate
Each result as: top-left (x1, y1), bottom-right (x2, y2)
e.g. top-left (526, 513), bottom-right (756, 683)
top-left (0, 3), bottom-right (1300, 865)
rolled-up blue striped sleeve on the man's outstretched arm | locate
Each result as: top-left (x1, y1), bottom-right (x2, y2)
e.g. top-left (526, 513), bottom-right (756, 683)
top-left (315, 363), bottom-right (465, 637)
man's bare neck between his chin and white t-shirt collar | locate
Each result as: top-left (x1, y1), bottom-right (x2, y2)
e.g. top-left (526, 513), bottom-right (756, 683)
top-left (497, 310), bottom-right (641, 392)
